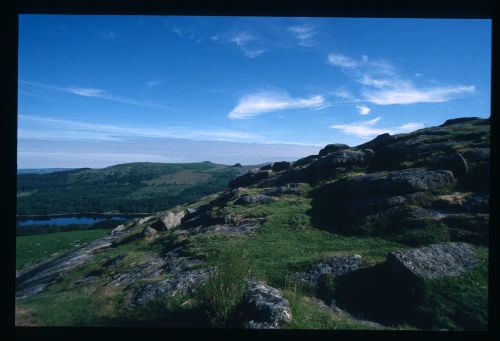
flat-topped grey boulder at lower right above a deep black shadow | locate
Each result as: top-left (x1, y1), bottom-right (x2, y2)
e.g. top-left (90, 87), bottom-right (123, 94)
top-left (387, 242), bottom-right (481, 279)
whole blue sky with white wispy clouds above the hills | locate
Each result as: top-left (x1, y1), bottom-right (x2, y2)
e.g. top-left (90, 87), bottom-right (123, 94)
top-left (18, 15), bottom-right (491, 168)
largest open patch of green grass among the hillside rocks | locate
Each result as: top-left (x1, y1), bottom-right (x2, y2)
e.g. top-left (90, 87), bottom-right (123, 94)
top-left (188, 198), bottom-right (404, 287)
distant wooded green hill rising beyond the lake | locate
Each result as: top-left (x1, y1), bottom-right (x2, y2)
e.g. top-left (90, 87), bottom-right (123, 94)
top-left (17, 162), bottom-right (252, 215)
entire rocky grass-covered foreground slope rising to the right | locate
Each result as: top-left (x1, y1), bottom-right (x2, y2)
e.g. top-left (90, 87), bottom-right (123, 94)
top-left (16, 118), bottom-right (490, 329)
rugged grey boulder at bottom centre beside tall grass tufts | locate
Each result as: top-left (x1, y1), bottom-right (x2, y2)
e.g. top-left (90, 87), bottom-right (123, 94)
top-left (242, 281), bottom-right (292, 329)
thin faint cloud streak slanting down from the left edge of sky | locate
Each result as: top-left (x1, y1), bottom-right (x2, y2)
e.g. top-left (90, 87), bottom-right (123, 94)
top-left (19, 80), bottom-right (172, 109)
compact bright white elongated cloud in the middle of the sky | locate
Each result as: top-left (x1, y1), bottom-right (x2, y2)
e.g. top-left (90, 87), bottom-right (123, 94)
top-left (228, 91), bottom-right (326, 119)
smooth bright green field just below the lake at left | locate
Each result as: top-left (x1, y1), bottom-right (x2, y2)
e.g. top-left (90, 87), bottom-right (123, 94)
top-left (16, 229), bottom-right (109, 270)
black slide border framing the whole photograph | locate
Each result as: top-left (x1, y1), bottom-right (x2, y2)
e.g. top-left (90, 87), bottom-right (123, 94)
top-left (6, 0), bottom-right (500, 339)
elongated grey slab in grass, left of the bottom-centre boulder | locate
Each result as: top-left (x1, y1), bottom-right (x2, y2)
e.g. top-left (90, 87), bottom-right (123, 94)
top-left (129, 268), bottom-right (213, 308)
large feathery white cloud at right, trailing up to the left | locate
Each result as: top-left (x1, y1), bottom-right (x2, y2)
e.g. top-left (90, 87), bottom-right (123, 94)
top-left (328, 53), bottom-right (475, 105)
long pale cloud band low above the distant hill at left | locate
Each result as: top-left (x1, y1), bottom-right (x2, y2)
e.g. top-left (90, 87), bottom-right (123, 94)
top-left (18, 114), bottom-right (264, 142)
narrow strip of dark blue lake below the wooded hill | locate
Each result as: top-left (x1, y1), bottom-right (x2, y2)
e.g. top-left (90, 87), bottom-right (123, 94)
top-left (17, 214), bottom-right (146, 226)
